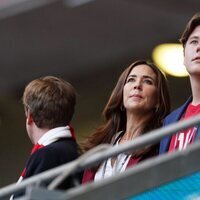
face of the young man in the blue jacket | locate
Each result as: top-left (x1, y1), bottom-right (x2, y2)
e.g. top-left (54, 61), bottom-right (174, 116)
top-left (184, 25), bottom-right (200, 75)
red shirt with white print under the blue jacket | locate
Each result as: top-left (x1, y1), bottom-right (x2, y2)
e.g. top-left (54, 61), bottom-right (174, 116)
top-left (169, 104), bottom-right (200, 152)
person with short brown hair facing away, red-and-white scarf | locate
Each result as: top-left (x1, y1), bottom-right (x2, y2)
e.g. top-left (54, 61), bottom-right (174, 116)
top-left (18, 76), bottom-right (79, 188)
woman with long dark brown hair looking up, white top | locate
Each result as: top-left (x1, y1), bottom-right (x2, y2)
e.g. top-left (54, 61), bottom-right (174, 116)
top-left (82, 61), bottom-right (170, 183)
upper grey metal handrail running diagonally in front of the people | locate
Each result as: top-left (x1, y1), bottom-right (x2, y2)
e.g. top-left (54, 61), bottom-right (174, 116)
top-left (0, 115), bottom-right (200, 198)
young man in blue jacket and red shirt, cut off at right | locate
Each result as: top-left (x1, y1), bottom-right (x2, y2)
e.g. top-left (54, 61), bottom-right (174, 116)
top-left (160, 13), bottom-right (200, 154)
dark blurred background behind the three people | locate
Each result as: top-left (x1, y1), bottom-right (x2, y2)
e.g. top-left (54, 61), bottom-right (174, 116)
top-left (0, 0), bottom-right (197, 187)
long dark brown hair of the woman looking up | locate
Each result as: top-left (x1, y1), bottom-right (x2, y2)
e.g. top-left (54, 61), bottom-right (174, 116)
top-left (82, 60), bottom-right (170, 155)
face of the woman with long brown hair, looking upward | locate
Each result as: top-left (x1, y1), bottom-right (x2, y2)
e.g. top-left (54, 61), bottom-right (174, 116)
top-left (123, 64), bottom-right (157, 114)
